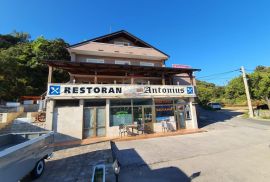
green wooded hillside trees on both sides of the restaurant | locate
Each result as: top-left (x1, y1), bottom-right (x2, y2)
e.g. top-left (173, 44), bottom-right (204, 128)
top-left (0, 31), bottom-right (270, 108)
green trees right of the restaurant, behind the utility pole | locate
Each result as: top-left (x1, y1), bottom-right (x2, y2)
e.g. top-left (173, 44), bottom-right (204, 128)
top-left (197, 66), bottom-right (270, 108)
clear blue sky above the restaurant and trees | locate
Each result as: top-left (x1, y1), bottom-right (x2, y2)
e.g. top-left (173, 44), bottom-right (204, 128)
top-left (0, 0), bottom-right (270, 85)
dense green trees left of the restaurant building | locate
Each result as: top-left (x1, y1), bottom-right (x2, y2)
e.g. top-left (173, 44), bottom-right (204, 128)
top-left (0, 32), bottom-right (70, 100)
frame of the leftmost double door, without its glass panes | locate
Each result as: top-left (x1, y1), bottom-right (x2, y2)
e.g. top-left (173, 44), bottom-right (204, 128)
top-left (82, 106), bottom-right (107, 139)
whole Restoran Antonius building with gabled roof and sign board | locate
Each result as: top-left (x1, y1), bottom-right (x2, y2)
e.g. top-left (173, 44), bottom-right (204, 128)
top-left (46, 30), bottom-right (199, 139)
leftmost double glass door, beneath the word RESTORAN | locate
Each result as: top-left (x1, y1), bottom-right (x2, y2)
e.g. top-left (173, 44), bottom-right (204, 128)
top-left (83, 107), bottom-right (106, 138)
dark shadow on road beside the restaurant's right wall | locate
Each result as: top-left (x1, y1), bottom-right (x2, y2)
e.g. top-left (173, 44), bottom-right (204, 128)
top-left (197, 107), bottom-right (243, 128)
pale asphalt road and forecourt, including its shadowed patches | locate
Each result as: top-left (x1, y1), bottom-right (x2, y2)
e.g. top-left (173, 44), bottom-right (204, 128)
top-left (113, 109), bottom-right (270, 182)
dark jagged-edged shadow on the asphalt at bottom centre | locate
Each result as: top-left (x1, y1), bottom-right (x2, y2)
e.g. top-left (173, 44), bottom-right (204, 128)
top-left (111, 142), bottom-right (200, 182)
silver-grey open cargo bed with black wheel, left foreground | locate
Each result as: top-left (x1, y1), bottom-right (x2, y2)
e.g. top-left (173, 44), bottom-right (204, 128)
top-left (0, 132), bottom-right (54, 182)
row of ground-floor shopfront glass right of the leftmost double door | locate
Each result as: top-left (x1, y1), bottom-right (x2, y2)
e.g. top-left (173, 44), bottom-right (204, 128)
top-left (106, 98), bottom-right (191, 126)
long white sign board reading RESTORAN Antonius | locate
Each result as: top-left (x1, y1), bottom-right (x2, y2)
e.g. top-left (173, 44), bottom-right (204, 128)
top-left (47, 83), bottom-right (196, 99)
